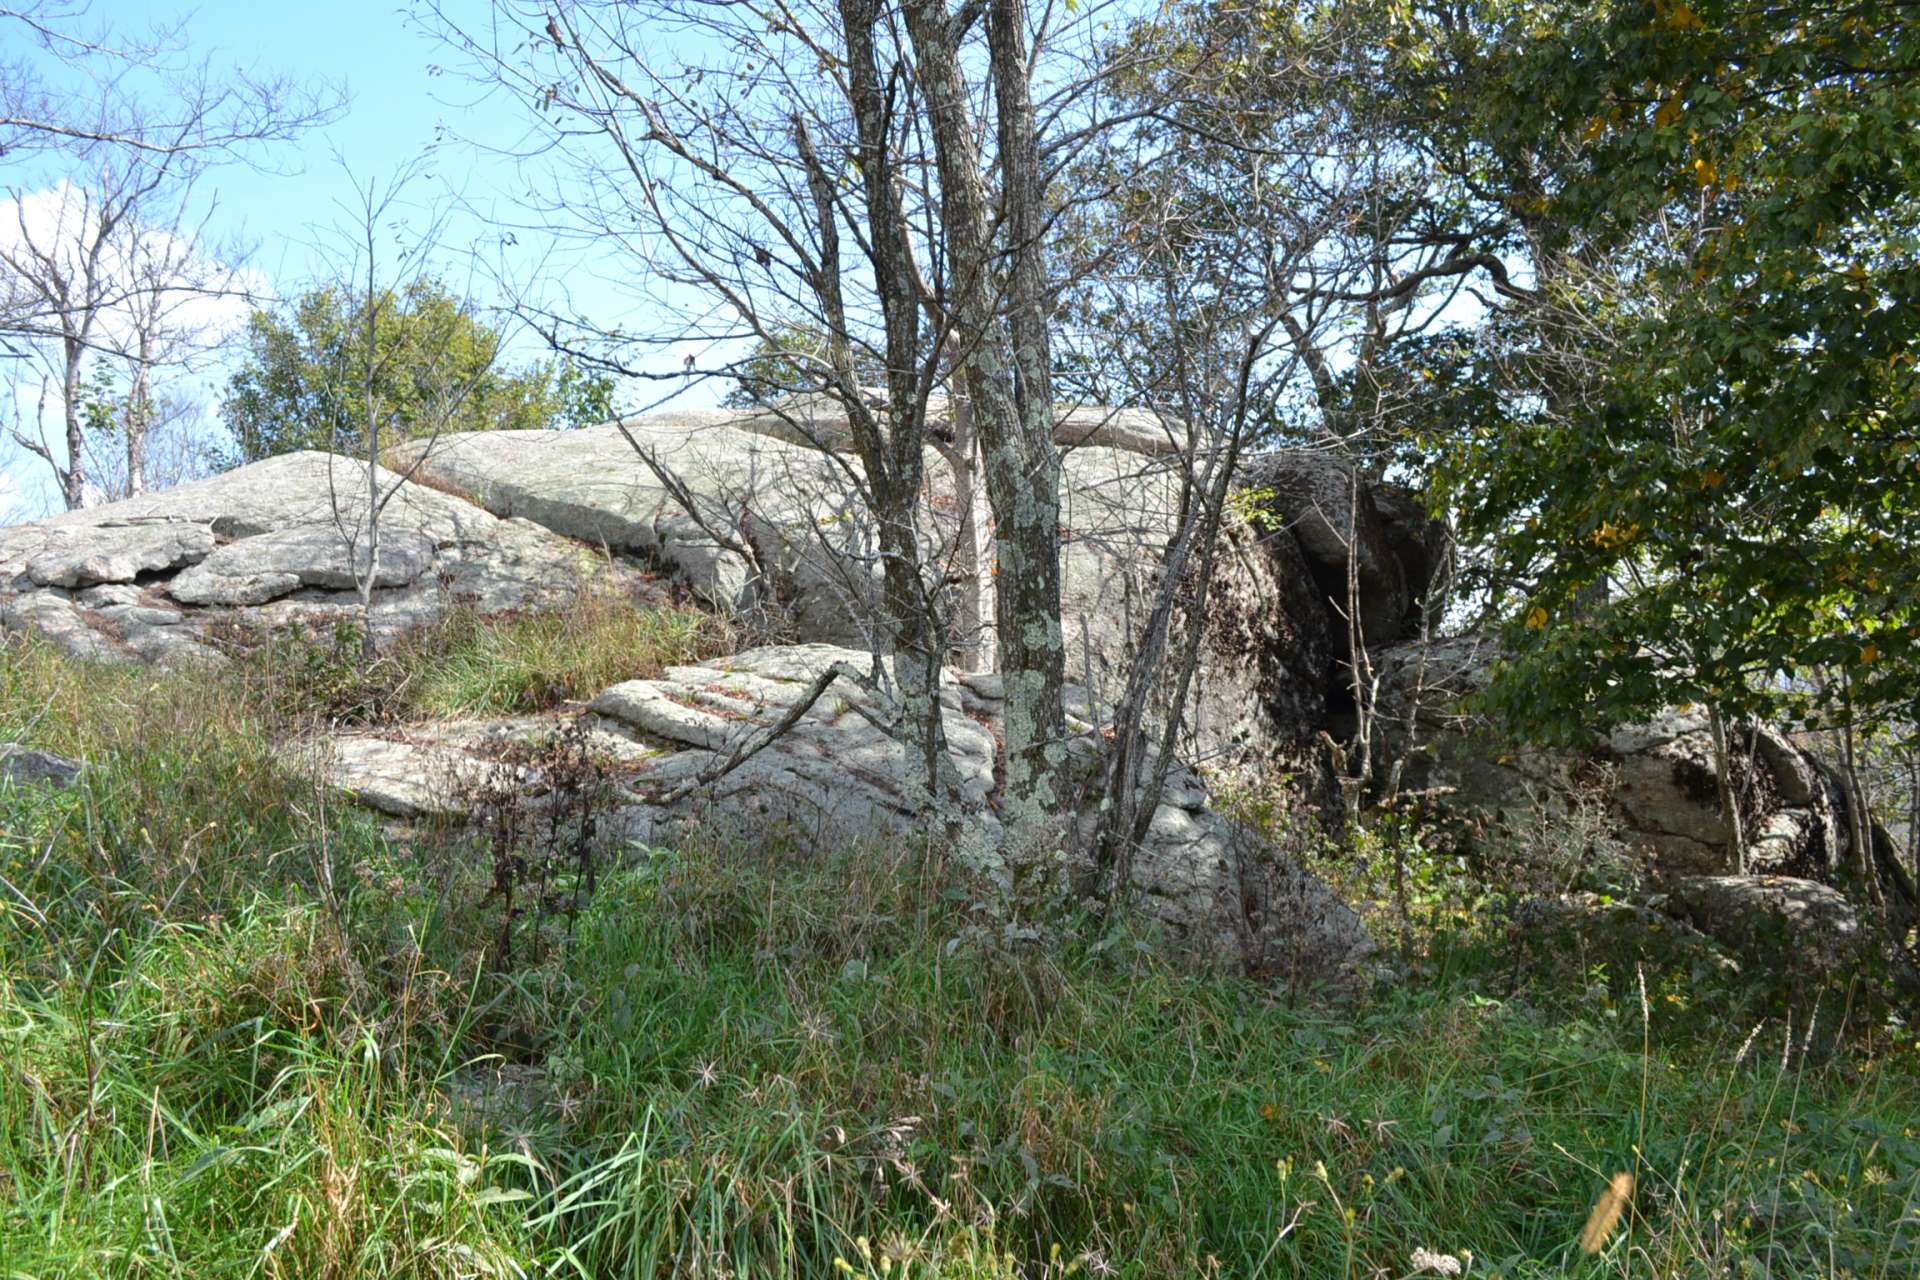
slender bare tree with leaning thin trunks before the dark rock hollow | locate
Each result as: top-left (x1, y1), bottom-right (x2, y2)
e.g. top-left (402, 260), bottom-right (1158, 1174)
top-left (1066, 4), bottom-right (1471, 892)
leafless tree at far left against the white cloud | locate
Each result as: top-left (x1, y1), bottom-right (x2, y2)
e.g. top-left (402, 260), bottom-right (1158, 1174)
top-left (0, 0), bottom-right (338, 509)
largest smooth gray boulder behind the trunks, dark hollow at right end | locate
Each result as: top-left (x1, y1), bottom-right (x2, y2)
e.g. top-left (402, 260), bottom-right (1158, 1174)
top-left (401, 405), bottom-right (1446, 764)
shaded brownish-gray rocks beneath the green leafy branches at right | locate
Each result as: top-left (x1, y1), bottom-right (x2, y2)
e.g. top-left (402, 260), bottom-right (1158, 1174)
top-left (1377, 635), bottom-right (1845, 879)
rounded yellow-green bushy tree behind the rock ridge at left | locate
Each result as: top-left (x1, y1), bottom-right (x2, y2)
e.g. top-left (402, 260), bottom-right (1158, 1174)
top-left (223, 278), bottom-right (612, 462)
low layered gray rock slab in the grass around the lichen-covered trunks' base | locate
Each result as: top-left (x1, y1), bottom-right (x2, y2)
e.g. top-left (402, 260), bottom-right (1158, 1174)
top-left (300, 645), bottom-right (1371, 979)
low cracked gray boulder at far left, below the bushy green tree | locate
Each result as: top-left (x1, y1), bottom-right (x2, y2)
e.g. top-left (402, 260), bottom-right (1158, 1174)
top-left (0, 453), bottom-right (659, 666)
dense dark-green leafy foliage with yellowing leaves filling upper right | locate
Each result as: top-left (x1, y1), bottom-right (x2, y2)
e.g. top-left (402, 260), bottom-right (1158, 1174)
top-left (1397, 0), bottom-right (1920, 733)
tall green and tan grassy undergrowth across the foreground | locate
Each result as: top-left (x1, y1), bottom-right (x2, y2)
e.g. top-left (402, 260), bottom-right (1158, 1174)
top-left (0, 645), bottom-right (1920, 1280)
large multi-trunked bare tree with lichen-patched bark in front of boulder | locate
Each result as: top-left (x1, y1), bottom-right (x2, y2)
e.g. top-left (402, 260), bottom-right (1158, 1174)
top-left (424, 0), bottom-right (1167, 825)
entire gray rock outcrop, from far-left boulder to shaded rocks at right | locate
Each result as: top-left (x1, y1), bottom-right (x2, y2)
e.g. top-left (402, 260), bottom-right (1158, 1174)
top-left (0, 405), bottom-right (1881, 971)
